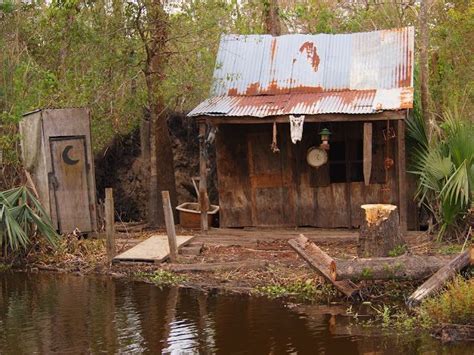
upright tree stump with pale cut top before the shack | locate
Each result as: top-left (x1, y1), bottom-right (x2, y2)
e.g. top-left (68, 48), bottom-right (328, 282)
top-left (357, 204), bottom-right (404, 258)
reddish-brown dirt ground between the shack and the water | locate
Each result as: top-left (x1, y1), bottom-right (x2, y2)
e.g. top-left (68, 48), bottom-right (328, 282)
top-left (20, 224), bottom-right (468, 302)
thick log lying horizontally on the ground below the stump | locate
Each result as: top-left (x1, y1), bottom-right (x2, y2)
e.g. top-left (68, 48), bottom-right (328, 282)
top-left (336, 255), bottom-right (450, 281)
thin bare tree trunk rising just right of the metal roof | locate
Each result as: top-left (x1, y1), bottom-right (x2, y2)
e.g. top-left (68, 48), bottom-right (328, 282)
top-left (418, 0), bottom-right (431, 131)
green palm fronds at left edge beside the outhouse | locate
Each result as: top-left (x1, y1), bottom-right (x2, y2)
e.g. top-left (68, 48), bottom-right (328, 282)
top-left (0, 186), bottom-right (58, 251)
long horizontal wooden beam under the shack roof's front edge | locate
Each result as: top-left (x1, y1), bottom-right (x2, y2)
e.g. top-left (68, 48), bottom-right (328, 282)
top-left (201, 110), bottom-right (406, 125)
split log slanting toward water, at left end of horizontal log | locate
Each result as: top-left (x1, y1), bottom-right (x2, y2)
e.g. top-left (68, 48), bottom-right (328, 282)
top-left (288, 234), bottom-right (359, 297)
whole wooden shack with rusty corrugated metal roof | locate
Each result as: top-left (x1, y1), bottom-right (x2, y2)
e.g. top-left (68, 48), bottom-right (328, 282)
top-left (189, 27), bottom-right (414, 234)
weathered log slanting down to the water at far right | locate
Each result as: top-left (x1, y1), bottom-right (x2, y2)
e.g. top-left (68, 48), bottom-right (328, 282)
top-left (407, 250), bottom-right (470, 307)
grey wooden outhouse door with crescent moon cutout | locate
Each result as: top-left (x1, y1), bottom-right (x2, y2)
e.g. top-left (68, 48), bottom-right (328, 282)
top-left (50, 136), bottom-right (92, 233)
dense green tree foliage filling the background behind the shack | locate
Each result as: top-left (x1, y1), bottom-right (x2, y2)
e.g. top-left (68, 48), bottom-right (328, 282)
top-left (0, 0), bottom-right (474, 234)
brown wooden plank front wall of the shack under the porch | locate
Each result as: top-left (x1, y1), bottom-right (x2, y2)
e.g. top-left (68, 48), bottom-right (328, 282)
top-left (216, 121), bottom-right (414, 228)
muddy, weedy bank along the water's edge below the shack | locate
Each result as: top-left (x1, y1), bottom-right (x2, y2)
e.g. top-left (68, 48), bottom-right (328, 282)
top-left (2, 225), bottom-right (470, 341)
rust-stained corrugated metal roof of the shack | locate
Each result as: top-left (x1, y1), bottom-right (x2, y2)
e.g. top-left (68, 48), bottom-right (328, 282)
top-left (189, 27), bottom-right (414, 117)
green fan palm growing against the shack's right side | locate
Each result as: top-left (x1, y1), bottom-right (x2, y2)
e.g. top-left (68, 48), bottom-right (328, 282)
top-left (407, 110), bottom-right (474, 239)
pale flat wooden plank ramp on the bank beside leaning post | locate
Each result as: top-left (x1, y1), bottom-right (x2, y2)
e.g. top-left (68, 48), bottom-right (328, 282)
top-left (112, 234), bottom-right (194, 263)
